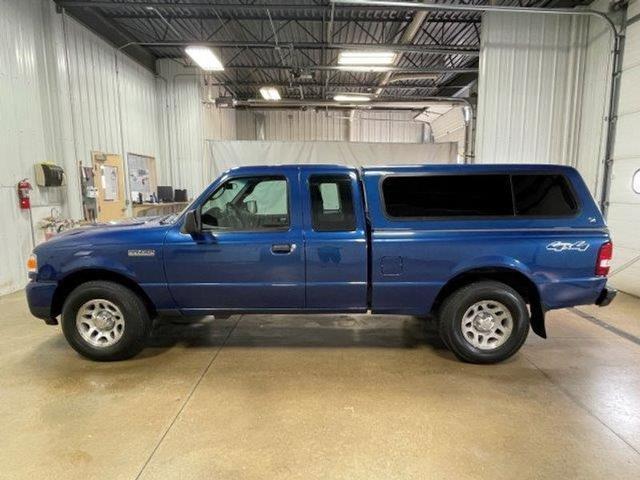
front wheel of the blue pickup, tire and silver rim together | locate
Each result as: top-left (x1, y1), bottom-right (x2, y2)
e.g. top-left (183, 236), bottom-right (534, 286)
top-left (61, 281), bottom-right (151, 361)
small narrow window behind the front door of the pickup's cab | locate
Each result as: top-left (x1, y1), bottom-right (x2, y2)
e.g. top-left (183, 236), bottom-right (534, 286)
top-left (309, 175), bottom-right (356, 232)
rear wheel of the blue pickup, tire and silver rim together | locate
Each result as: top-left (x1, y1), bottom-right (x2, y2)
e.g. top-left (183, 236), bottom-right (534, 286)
top-left (439, 281), bottom-right (529, 363)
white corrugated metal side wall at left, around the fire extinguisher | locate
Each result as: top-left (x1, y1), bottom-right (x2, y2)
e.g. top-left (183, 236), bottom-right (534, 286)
top-left (0, 0), bottom-right (161, 294)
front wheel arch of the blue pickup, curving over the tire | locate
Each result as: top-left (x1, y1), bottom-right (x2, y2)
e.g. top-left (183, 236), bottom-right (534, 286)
top-left (51, 268), bottom-right (156, 317)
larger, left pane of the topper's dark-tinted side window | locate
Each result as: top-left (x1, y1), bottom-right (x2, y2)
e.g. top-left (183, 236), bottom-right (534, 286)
top-left (382, 175), bottom-right (513, 218)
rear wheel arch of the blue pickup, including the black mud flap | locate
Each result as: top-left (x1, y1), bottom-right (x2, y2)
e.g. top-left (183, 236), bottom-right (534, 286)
top-left (431, 267), bottom-right (547, 338)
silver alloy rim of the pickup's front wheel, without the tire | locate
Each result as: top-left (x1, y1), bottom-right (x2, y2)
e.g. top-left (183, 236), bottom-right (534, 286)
top-left (76, 299), bottom-right (124, 348)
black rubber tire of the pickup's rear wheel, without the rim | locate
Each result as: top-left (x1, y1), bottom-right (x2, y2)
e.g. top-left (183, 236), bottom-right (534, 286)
top-left (439, 281), bottom-right (529, 364)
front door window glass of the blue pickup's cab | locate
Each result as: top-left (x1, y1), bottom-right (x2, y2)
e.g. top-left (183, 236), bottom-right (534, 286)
top-left (200, 176), bottom-right (289, 231)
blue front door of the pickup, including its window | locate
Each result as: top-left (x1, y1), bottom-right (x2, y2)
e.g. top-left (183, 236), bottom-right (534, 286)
top-left (164, 168), bottom-right (305, 313)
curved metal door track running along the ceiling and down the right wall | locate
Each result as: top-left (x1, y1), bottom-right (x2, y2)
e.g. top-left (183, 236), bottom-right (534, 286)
top-left (331, 0), bottom-right (624, 210)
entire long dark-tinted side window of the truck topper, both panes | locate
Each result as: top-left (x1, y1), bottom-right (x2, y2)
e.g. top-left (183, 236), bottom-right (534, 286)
top-left (382, 174), bottom-right (578, 218)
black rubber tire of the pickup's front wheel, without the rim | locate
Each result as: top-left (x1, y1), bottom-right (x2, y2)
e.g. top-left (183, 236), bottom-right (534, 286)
top-left (61, 281), bottom-right (151, 362)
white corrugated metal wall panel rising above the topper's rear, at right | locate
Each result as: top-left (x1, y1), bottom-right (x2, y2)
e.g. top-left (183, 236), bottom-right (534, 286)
top-left (476, 13), bottom-right (587, 170)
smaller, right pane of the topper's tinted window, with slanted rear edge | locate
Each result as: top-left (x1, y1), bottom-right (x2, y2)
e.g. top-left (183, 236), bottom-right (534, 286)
top-left (512, 175), bottom-right (578, 217)
